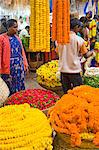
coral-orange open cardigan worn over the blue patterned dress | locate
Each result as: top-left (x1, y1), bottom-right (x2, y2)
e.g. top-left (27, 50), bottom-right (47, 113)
top-left (0, 33), bottom-right (28, 74)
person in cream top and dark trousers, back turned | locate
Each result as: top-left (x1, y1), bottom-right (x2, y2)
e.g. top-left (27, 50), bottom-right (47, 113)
top-left (58, 18), bottom-right (93, 93)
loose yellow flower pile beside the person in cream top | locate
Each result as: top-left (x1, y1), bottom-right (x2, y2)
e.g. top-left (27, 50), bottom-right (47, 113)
top-left (36, 60), bottom-right (61, 88)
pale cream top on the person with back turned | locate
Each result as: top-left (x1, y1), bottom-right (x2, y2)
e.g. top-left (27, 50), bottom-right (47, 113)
top-left (58, 31), bottom-right (84, 73)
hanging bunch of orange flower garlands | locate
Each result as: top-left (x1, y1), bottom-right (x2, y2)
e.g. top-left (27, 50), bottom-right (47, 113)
top-left (52, 0), bottom-right (70, 44)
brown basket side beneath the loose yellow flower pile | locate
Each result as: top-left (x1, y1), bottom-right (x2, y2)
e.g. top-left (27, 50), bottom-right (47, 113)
top-left (39, 84), bottom-right (64, 97)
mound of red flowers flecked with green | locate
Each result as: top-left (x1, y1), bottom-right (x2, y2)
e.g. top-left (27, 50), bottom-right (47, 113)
top-left (5, 89), bottom-right (59, 110)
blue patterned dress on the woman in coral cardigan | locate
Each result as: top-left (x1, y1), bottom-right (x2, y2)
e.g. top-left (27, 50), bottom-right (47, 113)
top-left (2, 36), bottom-right (25, 95)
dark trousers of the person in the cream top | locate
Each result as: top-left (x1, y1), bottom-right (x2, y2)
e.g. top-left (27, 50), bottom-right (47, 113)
top-left (61, 72), bottom-right (82, 94)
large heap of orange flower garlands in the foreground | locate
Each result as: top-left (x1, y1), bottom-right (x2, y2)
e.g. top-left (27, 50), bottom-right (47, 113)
top-left (48, 85), bottom-right (99, 146)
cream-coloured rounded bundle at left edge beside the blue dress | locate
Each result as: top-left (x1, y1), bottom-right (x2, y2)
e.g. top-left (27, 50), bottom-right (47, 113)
top-left (0, 77), bottom-right (10, 107)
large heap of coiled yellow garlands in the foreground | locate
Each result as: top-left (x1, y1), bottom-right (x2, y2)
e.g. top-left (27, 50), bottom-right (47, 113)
top-left (0, 104), bottom-right (52, 150)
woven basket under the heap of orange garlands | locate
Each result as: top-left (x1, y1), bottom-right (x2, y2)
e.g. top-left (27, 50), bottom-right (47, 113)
top-left (53, 133), bottom-right (99, 150)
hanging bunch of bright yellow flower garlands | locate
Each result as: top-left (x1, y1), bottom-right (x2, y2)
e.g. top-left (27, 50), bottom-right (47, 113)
top-left (30, 0), bottom-right (50, 52)
